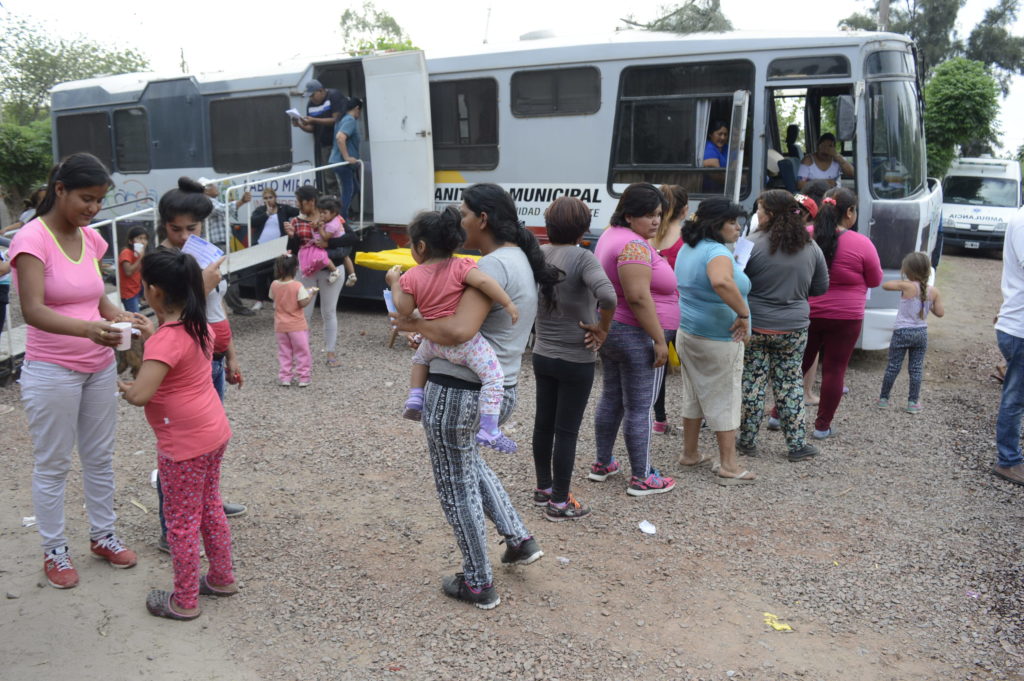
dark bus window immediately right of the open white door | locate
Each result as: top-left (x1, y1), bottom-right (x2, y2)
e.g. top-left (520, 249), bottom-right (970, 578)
top-left (430, 78), bottom-right (498, 170)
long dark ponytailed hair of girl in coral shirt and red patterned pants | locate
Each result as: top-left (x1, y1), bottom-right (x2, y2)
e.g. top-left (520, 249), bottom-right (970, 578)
top-left (142, 249), bottom-right (213, 357)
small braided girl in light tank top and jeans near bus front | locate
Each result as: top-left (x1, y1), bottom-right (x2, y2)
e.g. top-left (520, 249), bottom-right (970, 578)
top-left (878, 252), bottom-right (945, 414)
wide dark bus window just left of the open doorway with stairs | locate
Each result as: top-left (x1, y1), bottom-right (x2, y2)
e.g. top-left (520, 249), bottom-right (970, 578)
top-left (210, 94), bottom-right (292, 173)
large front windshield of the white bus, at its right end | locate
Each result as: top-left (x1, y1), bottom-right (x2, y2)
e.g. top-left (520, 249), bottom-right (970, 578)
top-left (867, 80), bottom-right (926, 199)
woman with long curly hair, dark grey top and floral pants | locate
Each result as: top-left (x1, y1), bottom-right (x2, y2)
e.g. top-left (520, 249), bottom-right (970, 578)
top-left (736, 189), bottom-right (828, 461)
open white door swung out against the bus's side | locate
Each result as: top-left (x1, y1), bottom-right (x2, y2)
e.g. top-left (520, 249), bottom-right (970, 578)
top-left (362, 50), bottom-right (434, 224)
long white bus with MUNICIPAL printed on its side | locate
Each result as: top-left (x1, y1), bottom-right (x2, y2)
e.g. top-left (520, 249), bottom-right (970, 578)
top-left (52, 32), bottom-right (942, 349)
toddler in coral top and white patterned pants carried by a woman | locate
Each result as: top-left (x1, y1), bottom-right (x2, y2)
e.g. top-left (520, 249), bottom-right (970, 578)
top-left (384, 206), bottom-right (519, 454)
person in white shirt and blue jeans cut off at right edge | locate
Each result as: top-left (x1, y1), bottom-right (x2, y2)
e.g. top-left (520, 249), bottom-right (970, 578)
top-left (992, 208), bottom-right (1024, 485)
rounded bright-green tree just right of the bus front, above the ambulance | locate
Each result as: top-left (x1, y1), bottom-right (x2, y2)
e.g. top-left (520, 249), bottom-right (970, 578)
top-left (925, 57), bottom-right (999, 177)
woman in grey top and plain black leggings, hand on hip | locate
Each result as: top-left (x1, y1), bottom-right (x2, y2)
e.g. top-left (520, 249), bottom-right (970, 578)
top-left (534, 197), bottom-right (615, 522)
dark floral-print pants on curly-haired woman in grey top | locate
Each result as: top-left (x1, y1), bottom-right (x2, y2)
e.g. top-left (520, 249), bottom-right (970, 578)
top-left (738, 329), bottom-right (807, 452)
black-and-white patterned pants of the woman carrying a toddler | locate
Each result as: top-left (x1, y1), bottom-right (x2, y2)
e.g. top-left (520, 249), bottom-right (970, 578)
top-left (421, 378), bottom-right (529, 589)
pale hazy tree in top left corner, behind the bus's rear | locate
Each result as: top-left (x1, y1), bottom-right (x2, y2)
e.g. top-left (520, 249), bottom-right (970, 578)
top-left (0, 14), bottom-right (148, 125)
